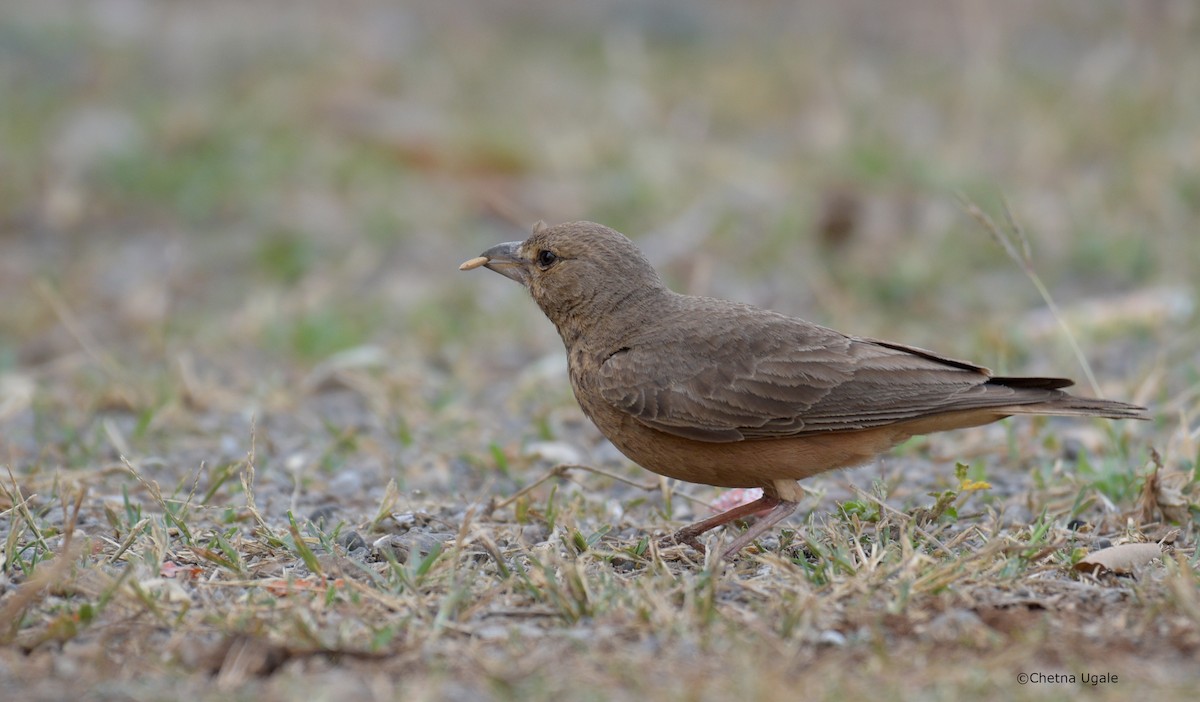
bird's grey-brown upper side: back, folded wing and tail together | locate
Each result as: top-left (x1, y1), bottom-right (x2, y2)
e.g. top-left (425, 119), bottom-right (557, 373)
top-left (572, 293), bottom-right (1144, 443)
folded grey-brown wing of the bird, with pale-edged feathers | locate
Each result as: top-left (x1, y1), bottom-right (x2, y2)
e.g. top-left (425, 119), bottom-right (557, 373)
top-left (595, 313), bottom-right (1067, 442)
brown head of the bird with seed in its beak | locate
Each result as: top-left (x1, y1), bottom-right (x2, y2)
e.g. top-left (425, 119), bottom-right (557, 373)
top-left (460, 222), bottom-right (666, 337)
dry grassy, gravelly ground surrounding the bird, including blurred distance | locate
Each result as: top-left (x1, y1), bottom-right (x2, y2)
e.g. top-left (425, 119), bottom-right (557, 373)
top-left (0, 0), bottom-right (1200, 701)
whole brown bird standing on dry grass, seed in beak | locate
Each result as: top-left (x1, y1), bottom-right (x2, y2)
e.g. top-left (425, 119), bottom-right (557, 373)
top-left (460, 222), bottom-right (1146, 558)
